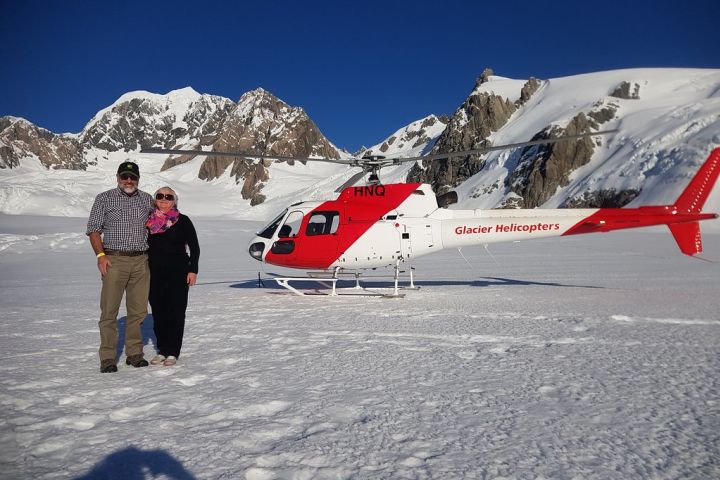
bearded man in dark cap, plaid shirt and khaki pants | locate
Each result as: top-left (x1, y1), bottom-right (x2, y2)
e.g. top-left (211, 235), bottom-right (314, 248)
top-left (86, 162), bottom-right (153, 373)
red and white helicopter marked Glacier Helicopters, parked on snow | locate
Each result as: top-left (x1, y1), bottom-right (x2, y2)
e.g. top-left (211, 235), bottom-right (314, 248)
top-left (142, 130), bottom-right (720, 296)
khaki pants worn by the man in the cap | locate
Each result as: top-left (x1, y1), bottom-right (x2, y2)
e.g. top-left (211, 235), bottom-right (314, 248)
top-left (98, 255), bottom-right (150, 362)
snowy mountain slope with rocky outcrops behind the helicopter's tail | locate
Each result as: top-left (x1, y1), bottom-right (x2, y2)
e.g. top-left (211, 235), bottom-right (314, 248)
top-left (414, 69), bottom-right (720, 212)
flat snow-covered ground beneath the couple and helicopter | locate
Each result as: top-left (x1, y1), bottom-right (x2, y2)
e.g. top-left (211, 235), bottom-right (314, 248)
top-left (0, 215), bottom-right (720, 480)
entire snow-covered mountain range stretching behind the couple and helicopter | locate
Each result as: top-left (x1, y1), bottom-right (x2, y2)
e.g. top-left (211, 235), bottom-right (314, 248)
top-left (0, 69), bottom-right (720, 223)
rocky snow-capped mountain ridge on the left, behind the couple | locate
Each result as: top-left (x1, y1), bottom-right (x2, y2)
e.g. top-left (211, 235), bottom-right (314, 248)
top-left (0, 88), bottom-right (340, 212)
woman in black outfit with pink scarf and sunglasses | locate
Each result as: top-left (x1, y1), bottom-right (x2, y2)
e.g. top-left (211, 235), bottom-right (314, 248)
top-left (146, 187), bottom-right (200, 367)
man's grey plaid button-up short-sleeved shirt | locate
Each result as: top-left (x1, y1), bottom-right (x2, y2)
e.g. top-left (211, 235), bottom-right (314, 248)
top-left (86, 187), bottom-right (154, 252)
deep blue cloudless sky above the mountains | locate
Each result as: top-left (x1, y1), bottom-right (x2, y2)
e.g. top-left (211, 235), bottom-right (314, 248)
top-left (0, 0), bottom-right (720, 151)
